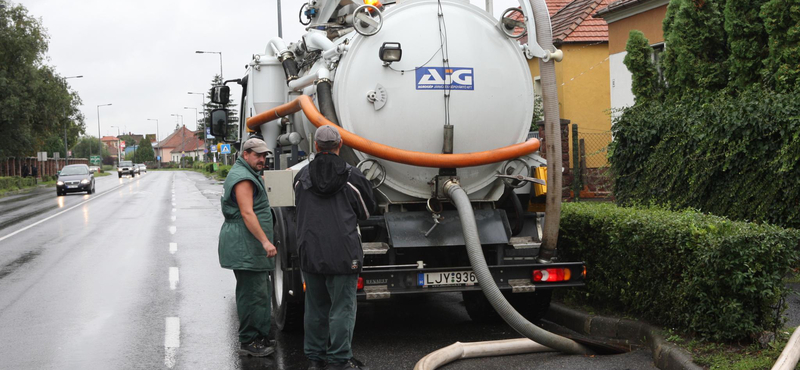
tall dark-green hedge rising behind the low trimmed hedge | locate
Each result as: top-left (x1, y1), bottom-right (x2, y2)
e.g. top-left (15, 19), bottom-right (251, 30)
top-left (609, 86), bottom-right (800, 228)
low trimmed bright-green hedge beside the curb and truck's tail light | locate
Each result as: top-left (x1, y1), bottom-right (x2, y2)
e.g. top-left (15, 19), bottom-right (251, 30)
top-left (559, 202), bottom-right (800, 340)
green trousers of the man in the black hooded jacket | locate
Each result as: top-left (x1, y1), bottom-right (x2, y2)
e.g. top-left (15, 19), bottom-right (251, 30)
top-left (303, 271), bottom-right (358, 364)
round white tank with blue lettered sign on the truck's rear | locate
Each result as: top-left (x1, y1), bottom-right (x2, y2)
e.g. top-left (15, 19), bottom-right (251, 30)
top-left (333, 0), bottom-right (534, 199)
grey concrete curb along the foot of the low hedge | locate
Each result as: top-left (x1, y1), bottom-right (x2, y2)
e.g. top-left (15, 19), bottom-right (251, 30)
top-left (545, 302), bottom-right (703, 370)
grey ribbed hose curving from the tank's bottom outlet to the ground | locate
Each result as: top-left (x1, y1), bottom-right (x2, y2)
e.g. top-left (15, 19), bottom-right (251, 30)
top-left (444, 181), bottom-right (594, 355)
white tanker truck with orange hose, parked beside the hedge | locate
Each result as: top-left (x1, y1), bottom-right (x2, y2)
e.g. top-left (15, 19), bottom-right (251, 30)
top-left (211, 0), bottom-right (585, 330)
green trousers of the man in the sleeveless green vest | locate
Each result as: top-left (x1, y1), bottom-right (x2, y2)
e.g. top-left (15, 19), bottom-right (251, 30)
top-left (233, 270), bottom-right (272, 343)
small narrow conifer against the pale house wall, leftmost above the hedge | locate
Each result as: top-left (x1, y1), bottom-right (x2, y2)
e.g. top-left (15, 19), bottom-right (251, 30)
top-left (623, 30), bottom-right (661, 103)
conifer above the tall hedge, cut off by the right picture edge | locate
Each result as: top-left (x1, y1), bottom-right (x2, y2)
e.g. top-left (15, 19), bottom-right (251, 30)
top-left (760, 0), bottom-right (800, 92)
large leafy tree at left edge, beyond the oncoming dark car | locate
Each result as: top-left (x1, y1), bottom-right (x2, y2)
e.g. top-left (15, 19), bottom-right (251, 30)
top-left (0, 5), bottom-right (84, 158)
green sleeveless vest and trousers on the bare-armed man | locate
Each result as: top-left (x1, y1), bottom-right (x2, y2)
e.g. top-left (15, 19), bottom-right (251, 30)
top-left (219, 157), bottom-right (275, 343)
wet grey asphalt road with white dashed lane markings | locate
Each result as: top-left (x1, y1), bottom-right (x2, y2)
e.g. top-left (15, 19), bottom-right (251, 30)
top-left (0, 171), bottom-right (655, 370)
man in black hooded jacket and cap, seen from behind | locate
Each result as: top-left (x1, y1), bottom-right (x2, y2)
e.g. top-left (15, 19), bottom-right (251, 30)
top-left (294, 126), bottom-right (375, 370)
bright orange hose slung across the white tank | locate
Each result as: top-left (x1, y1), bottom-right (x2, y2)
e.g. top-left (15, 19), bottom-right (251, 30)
top-left (247, 95), bottom-right (539, 168)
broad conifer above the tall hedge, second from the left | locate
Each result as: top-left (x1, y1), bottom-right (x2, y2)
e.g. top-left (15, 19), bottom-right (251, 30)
top-left (663, 0), bottom-right (730, 96)
